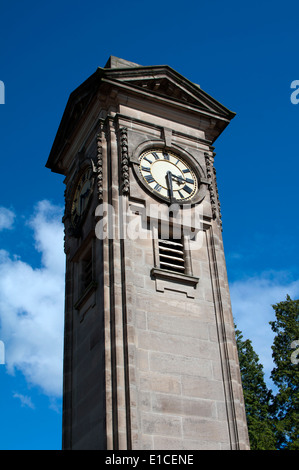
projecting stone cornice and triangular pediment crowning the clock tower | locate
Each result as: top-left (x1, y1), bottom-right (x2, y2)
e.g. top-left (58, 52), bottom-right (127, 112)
top-left (46, 56), bottom-right (235, 172)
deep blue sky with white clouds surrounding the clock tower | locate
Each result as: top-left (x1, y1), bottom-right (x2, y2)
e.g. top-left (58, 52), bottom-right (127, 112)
top-left (0, 0), bottom-right (299, 449)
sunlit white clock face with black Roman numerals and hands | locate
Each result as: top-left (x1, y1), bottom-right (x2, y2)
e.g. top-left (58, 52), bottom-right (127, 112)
top-left (139, 149), bottom-right (198, 202)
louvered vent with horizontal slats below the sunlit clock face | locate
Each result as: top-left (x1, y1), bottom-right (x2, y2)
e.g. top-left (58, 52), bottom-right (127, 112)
top-left (159, 239), bottom-right (185, 273)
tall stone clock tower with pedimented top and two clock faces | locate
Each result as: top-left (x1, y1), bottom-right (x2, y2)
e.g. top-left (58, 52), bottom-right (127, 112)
top-left (47, 57), bottom-right (249, 450)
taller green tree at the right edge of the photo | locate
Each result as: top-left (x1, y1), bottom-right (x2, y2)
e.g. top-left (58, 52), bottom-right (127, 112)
top-left (270, 296), bottom-right (299, 450)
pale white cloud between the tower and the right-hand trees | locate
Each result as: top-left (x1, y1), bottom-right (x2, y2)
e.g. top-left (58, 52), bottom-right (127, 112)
top-left (230, 271), bottom-right (299, 386)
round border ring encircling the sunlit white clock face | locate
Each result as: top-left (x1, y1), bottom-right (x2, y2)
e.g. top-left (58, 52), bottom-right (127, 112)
top-left (131, 145), bottom-right (206, 206)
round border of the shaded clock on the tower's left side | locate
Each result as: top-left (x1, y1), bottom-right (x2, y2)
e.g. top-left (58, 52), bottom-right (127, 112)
top-left (68, 163), bottom-right (95, 232)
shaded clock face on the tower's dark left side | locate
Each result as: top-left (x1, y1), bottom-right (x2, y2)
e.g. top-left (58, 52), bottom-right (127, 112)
top-left (71, 168), bottom-right (92, 227)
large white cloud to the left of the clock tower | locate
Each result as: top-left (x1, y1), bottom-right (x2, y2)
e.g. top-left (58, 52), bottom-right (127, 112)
top-left (0, 201), bottom-right (64, 396)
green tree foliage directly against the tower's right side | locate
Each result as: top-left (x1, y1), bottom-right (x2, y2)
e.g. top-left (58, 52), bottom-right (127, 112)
top-left (236, 324), bottom-right (275, 450)
